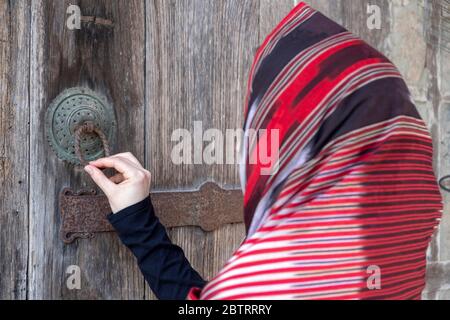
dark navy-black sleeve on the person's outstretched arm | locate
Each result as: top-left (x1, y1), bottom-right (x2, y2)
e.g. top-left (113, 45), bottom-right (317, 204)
top-left (108, 197), bottom-right (205, 300)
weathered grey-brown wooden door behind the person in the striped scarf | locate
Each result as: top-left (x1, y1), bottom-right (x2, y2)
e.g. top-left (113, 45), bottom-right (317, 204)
top-left (0, 0), bottom-right (450, 299)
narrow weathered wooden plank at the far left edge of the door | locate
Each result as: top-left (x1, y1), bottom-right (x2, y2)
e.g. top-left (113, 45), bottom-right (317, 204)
top-left (0, 0), bottom-right (30, 300)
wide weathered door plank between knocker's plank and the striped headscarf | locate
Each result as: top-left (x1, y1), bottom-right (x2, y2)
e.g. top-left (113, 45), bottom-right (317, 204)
top-left (146, 0), bottom-right (266, 297)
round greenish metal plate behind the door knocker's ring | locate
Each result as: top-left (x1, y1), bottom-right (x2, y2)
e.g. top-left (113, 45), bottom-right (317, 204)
top-left (45, 87), bottom-right (117, 165)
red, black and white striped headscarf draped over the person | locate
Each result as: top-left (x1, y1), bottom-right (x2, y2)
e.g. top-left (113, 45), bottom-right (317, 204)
top-left (191, 3), bottom-right (443, 299)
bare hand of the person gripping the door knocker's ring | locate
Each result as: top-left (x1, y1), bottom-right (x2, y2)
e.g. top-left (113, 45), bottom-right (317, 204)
top-left (84, 152), bottom-right (151, 213)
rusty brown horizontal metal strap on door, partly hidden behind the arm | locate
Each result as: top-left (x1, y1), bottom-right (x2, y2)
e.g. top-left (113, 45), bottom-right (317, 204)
top-left (59, 182), bottom-right (243, 243)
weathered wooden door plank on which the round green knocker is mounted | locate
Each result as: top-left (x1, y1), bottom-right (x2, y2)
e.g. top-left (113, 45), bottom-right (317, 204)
top-left (29, 0), bottom-right (145, 299)
